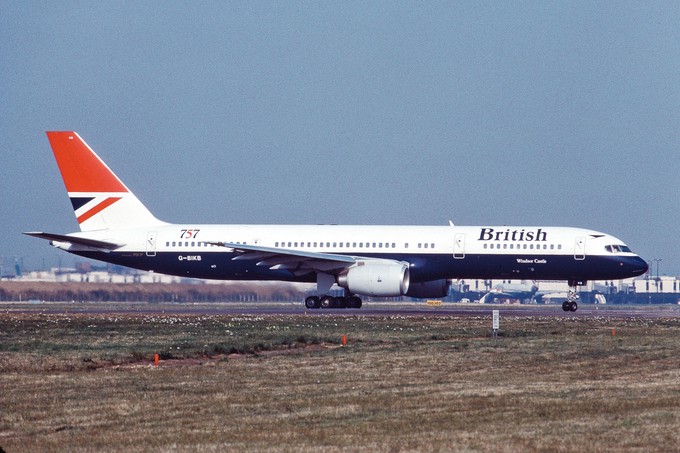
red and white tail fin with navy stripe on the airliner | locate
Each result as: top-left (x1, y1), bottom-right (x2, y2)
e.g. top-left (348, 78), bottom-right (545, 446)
top-left (47, 131), bottom-right (164, 231)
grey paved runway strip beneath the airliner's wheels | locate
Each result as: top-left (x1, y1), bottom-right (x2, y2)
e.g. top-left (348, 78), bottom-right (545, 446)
top-left (0, 302), bottom-right (680, 319)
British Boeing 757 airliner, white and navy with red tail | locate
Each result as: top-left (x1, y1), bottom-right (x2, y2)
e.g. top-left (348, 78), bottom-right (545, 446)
top-left (24, 131), bottom-right (648, 311)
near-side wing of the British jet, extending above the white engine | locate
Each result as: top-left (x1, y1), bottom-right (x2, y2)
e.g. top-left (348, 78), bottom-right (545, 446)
top-left (208, 242), bottom-right (358, 275)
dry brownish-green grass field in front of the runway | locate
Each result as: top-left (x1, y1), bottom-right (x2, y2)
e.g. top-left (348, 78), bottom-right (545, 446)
top-left (0, 302), bottom-right (680, 453)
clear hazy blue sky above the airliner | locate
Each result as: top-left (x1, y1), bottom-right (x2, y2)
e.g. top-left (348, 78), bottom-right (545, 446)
top-left (0, 0), bottom-right (680, 274)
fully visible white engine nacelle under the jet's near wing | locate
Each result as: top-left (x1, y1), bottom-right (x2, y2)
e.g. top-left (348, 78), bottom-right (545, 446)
top-left (338, 260), bottom-right (410, 297)
